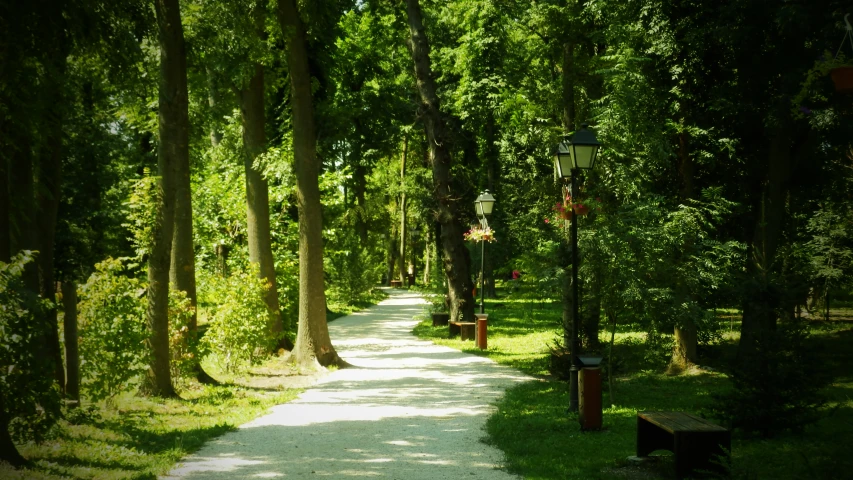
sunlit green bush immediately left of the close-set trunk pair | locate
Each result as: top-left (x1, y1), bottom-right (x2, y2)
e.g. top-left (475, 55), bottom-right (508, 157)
top-left (79, 258), bottom-right (148, 401)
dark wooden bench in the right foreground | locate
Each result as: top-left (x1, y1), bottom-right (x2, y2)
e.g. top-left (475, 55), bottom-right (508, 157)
top-left (637, 412), bottom-right (731, 478)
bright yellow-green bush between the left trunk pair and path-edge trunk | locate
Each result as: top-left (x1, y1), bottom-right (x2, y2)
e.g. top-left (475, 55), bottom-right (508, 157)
top-left (201, 264), bottom-right (278, 372)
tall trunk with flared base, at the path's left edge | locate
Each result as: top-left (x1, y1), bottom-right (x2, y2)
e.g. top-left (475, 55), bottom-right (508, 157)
top-left (278, 0), bottom-right (346, 367)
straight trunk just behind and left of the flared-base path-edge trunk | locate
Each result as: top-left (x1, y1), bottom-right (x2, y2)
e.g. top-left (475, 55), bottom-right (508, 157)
top-left (240, 64), bottom-right (293, 350)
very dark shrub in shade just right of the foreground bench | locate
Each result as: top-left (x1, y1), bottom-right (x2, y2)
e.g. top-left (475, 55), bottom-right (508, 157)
top-left (712, 320), bottom-right (831, 437)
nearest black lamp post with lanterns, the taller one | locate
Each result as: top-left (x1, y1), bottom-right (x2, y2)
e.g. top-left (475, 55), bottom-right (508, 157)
top-left (554, 123), bottom-right (601, 412)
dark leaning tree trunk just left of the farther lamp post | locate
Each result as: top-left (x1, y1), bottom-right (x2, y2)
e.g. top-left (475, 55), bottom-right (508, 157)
top-left (406, 0), bottom-right (474, 321)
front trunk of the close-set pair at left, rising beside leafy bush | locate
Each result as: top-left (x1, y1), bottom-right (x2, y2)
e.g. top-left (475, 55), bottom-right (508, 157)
top-left (146, 0), bottom-right (189, 397)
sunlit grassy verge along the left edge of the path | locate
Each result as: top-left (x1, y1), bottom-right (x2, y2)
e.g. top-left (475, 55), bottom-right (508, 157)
top-left (0, 385), bottom-right (300, 480)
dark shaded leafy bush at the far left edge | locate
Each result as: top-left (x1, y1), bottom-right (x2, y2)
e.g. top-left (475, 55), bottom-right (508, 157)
top-left (0, 251), bottom-right (60, 440)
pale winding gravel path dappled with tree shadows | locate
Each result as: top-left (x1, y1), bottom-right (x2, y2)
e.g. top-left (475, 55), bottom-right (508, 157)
top-left (163, 290), bottom-right (529, 480)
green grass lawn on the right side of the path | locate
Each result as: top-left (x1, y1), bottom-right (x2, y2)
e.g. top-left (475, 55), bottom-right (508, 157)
top-left (415, 288), bottom-right (853, 479)
